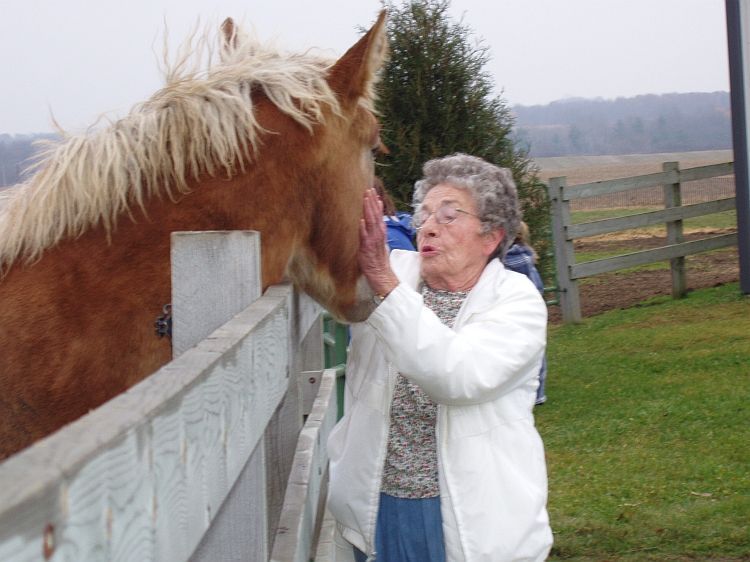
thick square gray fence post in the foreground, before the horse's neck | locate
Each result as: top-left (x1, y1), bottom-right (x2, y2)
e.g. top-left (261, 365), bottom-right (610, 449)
top-left (171, 231), bottom-right (272, 562)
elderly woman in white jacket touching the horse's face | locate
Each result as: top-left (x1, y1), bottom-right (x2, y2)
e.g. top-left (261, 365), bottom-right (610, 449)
top-left (328, 154), bottom-right (552, 562)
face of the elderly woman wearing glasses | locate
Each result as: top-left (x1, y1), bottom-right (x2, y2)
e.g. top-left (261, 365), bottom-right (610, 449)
top-left (417, 184), bottom-right (503, 291)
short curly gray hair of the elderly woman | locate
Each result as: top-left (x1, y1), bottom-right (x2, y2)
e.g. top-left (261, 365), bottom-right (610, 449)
top-left (413, 153), bottom-right (521, 260)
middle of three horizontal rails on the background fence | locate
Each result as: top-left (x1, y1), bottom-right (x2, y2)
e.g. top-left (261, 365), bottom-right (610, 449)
top-left (565, 197), bottom-right (735, 240)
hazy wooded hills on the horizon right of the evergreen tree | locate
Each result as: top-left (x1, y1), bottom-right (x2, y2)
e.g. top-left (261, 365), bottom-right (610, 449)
top-left (513, 92), bottom-right (732, 157)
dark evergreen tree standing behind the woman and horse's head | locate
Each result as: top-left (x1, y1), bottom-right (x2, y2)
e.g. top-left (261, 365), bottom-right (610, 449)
top-left (376, 0), bottom-right (550, 278)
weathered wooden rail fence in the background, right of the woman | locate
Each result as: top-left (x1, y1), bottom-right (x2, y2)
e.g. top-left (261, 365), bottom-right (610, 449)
top-left (548, 162), bottom-right (737, 323)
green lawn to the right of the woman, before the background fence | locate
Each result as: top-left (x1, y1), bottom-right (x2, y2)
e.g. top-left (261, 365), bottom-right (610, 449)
top-left (536, 284), bottom-right (750, 562)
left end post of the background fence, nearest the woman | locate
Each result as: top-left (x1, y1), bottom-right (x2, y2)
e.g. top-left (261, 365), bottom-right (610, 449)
top-left (548, 177), bottom-right (581, 323)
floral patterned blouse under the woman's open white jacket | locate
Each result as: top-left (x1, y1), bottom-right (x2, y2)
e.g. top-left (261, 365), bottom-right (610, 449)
top-left (380, 284), bottom-right (468, 499)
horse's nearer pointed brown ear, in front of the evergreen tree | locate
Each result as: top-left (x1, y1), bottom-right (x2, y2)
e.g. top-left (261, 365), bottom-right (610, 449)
top-left (328, 10), bottom-right (388, 105)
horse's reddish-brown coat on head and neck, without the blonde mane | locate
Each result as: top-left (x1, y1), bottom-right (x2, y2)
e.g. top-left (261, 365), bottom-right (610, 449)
top-left (0, 14), bottom-right (385, 458)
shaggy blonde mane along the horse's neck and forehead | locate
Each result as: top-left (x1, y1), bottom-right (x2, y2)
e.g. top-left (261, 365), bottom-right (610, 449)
top-left (0, 20), bottom-right (346, 268)
